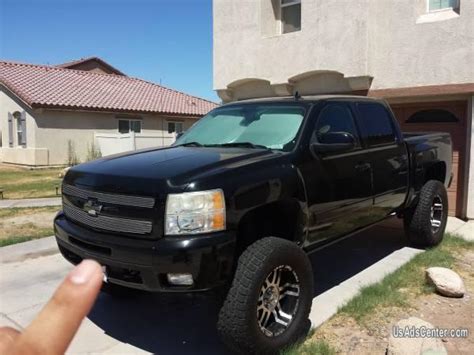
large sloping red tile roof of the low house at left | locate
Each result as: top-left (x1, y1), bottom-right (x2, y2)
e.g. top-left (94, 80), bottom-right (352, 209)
top-left (0, 61), bottom-right (217, 116)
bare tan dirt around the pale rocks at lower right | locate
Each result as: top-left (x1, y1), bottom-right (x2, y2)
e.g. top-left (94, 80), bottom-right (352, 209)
top-left (312, 250), bottom-right (474, 354)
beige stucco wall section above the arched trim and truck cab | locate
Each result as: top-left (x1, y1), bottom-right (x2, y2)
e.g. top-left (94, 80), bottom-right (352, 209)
top-left (213, 0), bottom-right (368, 89)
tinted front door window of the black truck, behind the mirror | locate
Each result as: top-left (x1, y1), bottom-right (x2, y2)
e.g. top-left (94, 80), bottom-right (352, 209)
top-left (313, 104), bottom-right (359, 146)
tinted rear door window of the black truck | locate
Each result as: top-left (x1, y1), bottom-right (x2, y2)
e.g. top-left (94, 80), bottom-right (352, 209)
top-left (357, 102), bottom-right (396, 146)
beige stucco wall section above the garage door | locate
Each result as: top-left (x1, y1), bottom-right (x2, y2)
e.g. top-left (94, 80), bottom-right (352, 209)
top-left (368, 0), bottom-right (474, 89)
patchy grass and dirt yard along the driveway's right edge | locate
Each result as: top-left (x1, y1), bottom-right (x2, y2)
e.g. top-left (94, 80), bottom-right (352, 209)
top-left (288, 234), bottom-right (474, 355)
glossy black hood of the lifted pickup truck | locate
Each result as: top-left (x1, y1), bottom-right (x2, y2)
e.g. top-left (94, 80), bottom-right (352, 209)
top-left (64, 147), bottom-right (278, 197)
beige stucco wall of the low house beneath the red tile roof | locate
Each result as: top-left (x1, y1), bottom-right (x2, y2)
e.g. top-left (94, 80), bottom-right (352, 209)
top-left (0, 90), bottom-right (196, 166)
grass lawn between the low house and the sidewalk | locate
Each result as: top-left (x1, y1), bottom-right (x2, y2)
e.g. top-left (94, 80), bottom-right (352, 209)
top-left (0, 165), bottom-right (62, 199)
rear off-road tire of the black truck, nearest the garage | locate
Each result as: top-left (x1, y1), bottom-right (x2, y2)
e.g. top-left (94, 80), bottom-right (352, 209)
top-left (403, 180), bottom-right (448, 247)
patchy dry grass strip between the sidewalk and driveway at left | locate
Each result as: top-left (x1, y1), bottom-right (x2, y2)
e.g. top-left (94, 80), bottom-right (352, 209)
top-left (0, 207), bottom-right (60, 247)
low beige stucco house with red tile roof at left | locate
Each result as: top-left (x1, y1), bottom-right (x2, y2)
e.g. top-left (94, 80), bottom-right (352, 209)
top-left (0, 57), bottom-right (216, 166)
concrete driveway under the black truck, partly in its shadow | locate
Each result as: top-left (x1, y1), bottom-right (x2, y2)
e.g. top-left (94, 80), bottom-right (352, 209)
top-left (0, 219), bottom-right (419, 354)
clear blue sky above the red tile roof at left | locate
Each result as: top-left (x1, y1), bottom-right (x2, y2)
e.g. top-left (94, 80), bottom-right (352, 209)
top-left (0, 0), bottom-right (219, 102)
